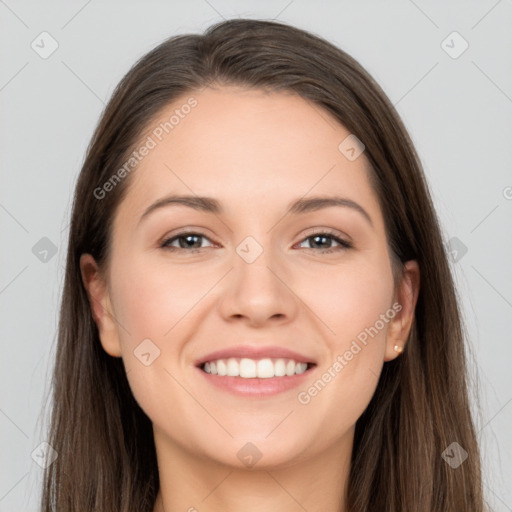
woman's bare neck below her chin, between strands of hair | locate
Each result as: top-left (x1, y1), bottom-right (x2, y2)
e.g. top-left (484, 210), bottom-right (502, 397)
top-left (153, 429), bottom-right (353, 512)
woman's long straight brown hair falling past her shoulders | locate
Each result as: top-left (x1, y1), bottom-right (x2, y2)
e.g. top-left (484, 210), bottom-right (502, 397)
top-left (42, 19), bottom-right (484, 512)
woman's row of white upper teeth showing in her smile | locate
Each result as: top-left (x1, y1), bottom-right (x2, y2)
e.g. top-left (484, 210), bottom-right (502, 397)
top-left (203, 357), bottom-right (308, 379)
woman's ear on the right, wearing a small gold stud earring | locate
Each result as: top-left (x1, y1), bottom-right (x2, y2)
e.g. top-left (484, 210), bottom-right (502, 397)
top-left (384, 260), bottom-right (420, 361)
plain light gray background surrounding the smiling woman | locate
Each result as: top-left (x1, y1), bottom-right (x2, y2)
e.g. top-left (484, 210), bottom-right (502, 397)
top-left (0, 0), bottom-right (512, 512)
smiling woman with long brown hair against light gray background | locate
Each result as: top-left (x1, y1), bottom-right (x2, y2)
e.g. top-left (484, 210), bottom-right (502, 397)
top-left (42, 19), bottom-right (484, 512)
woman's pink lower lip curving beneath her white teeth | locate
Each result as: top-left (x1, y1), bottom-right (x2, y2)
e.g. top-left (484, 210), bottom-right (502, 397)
top-left (197, 366), bottom-right (315, 397)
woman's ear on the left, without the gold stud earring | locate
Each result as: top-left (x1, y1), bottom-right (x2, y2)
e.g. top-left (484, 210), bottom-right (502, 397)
top-left (80, 254), bottom-right (121, 357)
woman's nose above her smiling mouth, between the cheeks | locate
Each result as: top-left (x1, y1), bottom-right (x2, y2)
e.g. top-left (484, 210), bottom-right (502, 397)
top-left (219, 240), bottom-right (300, 327)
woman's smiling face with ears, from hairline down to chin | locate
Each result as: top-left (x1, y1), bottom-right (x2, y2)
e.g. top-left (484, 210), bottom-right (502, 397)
top-left (82, 87), bottom-right (415, 467)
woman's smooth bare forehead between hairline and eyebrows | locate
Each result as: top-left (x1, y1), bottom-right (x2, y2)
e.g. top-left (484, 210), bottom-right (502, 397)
top-left (116, 87), bottom-right (376, 224)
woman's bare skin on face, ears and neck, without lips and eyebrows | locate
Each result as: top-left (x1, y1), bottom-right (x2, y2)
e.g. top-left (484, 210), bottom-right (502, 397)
top-left (81, 86), bottom-right (419, 512)
